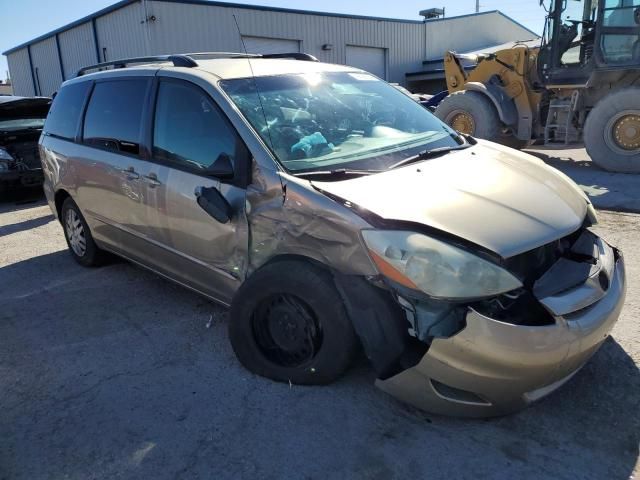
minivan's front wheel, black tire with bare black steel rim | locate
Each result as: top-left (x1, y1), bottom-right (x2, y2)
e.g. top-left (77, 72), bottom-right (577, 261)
top-left (229, 260), bottom-right (359, 385)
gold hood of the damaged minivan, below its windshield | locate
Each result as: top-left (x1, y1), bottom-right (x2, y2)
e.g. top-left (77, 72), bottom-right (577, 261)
top-left (313, 141), bottom-right (588, 258)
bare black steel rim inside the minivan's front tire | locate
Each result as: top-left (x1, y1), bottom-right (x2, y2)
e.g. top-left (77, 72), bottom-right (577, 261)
top-left (251, 294), bottom-right (322, 368)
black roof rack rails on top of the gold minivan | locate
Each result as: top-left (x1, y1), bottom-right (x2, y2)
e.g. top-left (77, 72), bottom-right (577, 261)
top-left (76, 52), bottom-right (319, 77)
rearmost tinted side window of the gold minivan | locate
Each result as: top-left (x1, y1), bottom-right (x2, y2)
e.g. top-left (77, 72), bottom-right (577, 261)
top-left (44, 82), bottom-right (91, 140)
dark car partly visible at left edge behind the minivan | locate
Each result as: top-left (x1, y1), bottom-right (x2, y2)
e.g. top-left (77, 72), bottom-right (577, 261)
top-left (0, 96), bottom-right (51, 193)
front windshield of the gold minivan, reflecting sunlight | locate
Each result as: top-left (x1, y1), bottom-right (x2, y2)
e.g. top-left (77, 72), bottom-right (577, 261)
top-left (220, 72), bottom-right (463, 173)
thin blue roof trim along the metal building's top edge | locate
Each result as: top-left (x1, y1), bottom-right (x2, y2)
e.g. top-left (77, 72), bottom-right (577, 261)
top-left (2, 0), bottom-right (537, 55)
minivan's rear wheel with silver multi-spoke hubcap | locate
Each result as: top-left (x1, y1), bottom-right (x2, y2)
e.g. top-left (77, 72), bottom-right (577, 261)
top-left (60, 197), bottom-right (106, 267)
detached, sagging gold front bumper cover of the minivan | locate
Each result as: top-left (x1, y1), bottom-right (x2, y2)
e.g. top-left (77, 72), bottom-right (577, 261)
top-left (376, 253), bottom-right (626, 417)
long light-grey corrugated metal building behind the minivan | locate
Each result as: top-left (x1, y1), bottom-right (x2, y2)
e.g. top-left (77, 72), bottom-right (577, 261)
top-left (4, 0), bottom-right (536, 96)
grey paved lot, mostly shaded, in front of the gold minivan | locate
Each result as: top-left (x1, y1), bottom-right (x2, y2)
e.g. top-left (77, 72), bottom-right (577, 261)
top-left (0, 163), bottom-right (640, 480)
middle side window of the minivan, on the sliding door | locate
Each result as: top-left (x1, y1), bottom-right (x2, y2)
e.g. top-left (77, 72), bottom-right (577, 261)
top-left (82, 79), bottom-right (149, 155)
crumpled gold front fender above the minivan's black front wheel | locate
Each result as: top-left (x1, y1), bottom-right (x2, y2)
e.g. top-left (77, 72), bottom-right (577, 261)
top-left (246, 168), bottom-right (377, 275)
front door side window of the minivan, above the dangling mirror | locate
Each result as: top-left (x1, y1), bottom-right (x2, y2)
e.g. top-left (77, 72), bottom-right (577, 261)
top-left (153, 81), bottom-right (237, 171)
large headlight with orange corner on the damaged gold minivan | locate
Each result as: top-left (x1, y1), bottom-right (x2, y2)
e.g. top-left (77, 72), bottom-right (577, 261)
top-left (362, 230), bottom-right (522, 300)
